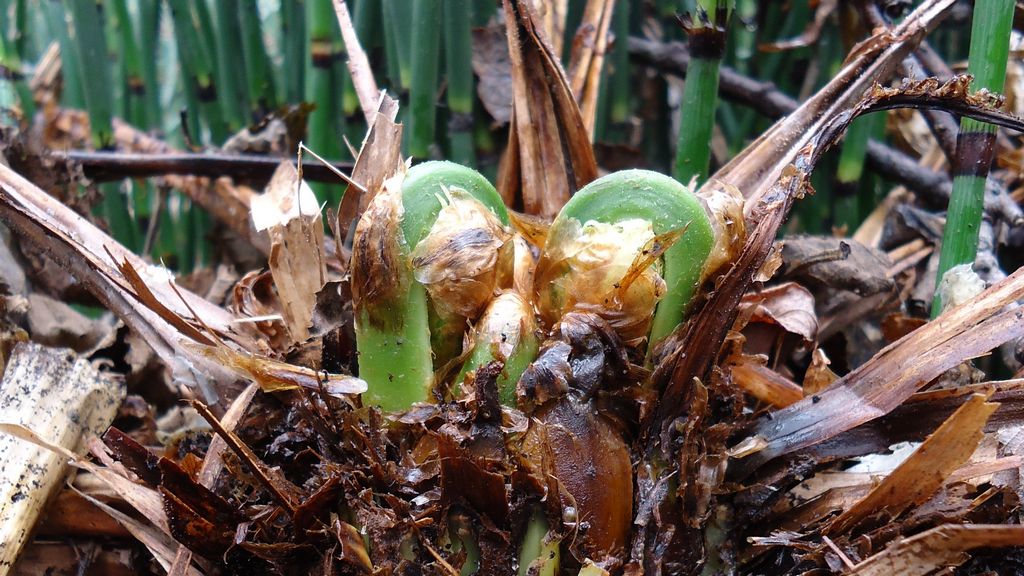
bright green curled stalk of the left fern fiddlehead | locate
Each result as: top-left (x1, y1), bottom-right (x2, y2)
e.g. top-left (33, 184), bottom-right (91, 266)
top-left (353, 162), bottom-right (508, 411)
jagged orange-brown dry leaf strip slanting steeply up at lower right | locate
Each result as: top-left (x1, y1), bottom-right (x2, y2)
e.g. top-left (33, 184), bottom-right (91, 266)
top-left (825, 394), bottom-right (999, 534)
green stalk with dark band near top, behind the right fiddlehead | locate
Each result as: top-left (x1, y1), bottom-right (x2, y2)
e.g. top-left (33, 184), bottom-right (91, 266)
top-left (673, 0), bottom-right (731, 182)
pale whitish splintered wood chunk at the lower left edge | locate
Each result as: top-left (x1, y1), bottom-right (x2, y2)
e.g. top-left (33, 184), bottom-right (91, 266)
top-left (0, 343), bottom-right (125, 576)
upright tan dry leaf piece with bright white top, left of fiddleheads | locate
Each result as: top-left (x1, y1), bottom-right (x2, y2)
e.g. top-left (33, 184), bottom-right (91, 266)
top-left (251, 161), bottom-right (327, 343)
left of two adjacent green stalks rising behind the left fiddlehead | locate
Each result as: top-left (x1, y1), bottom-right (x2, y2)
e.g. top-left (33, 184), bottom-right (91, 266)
top-left (409, 0), bottom-right (441, 159)
